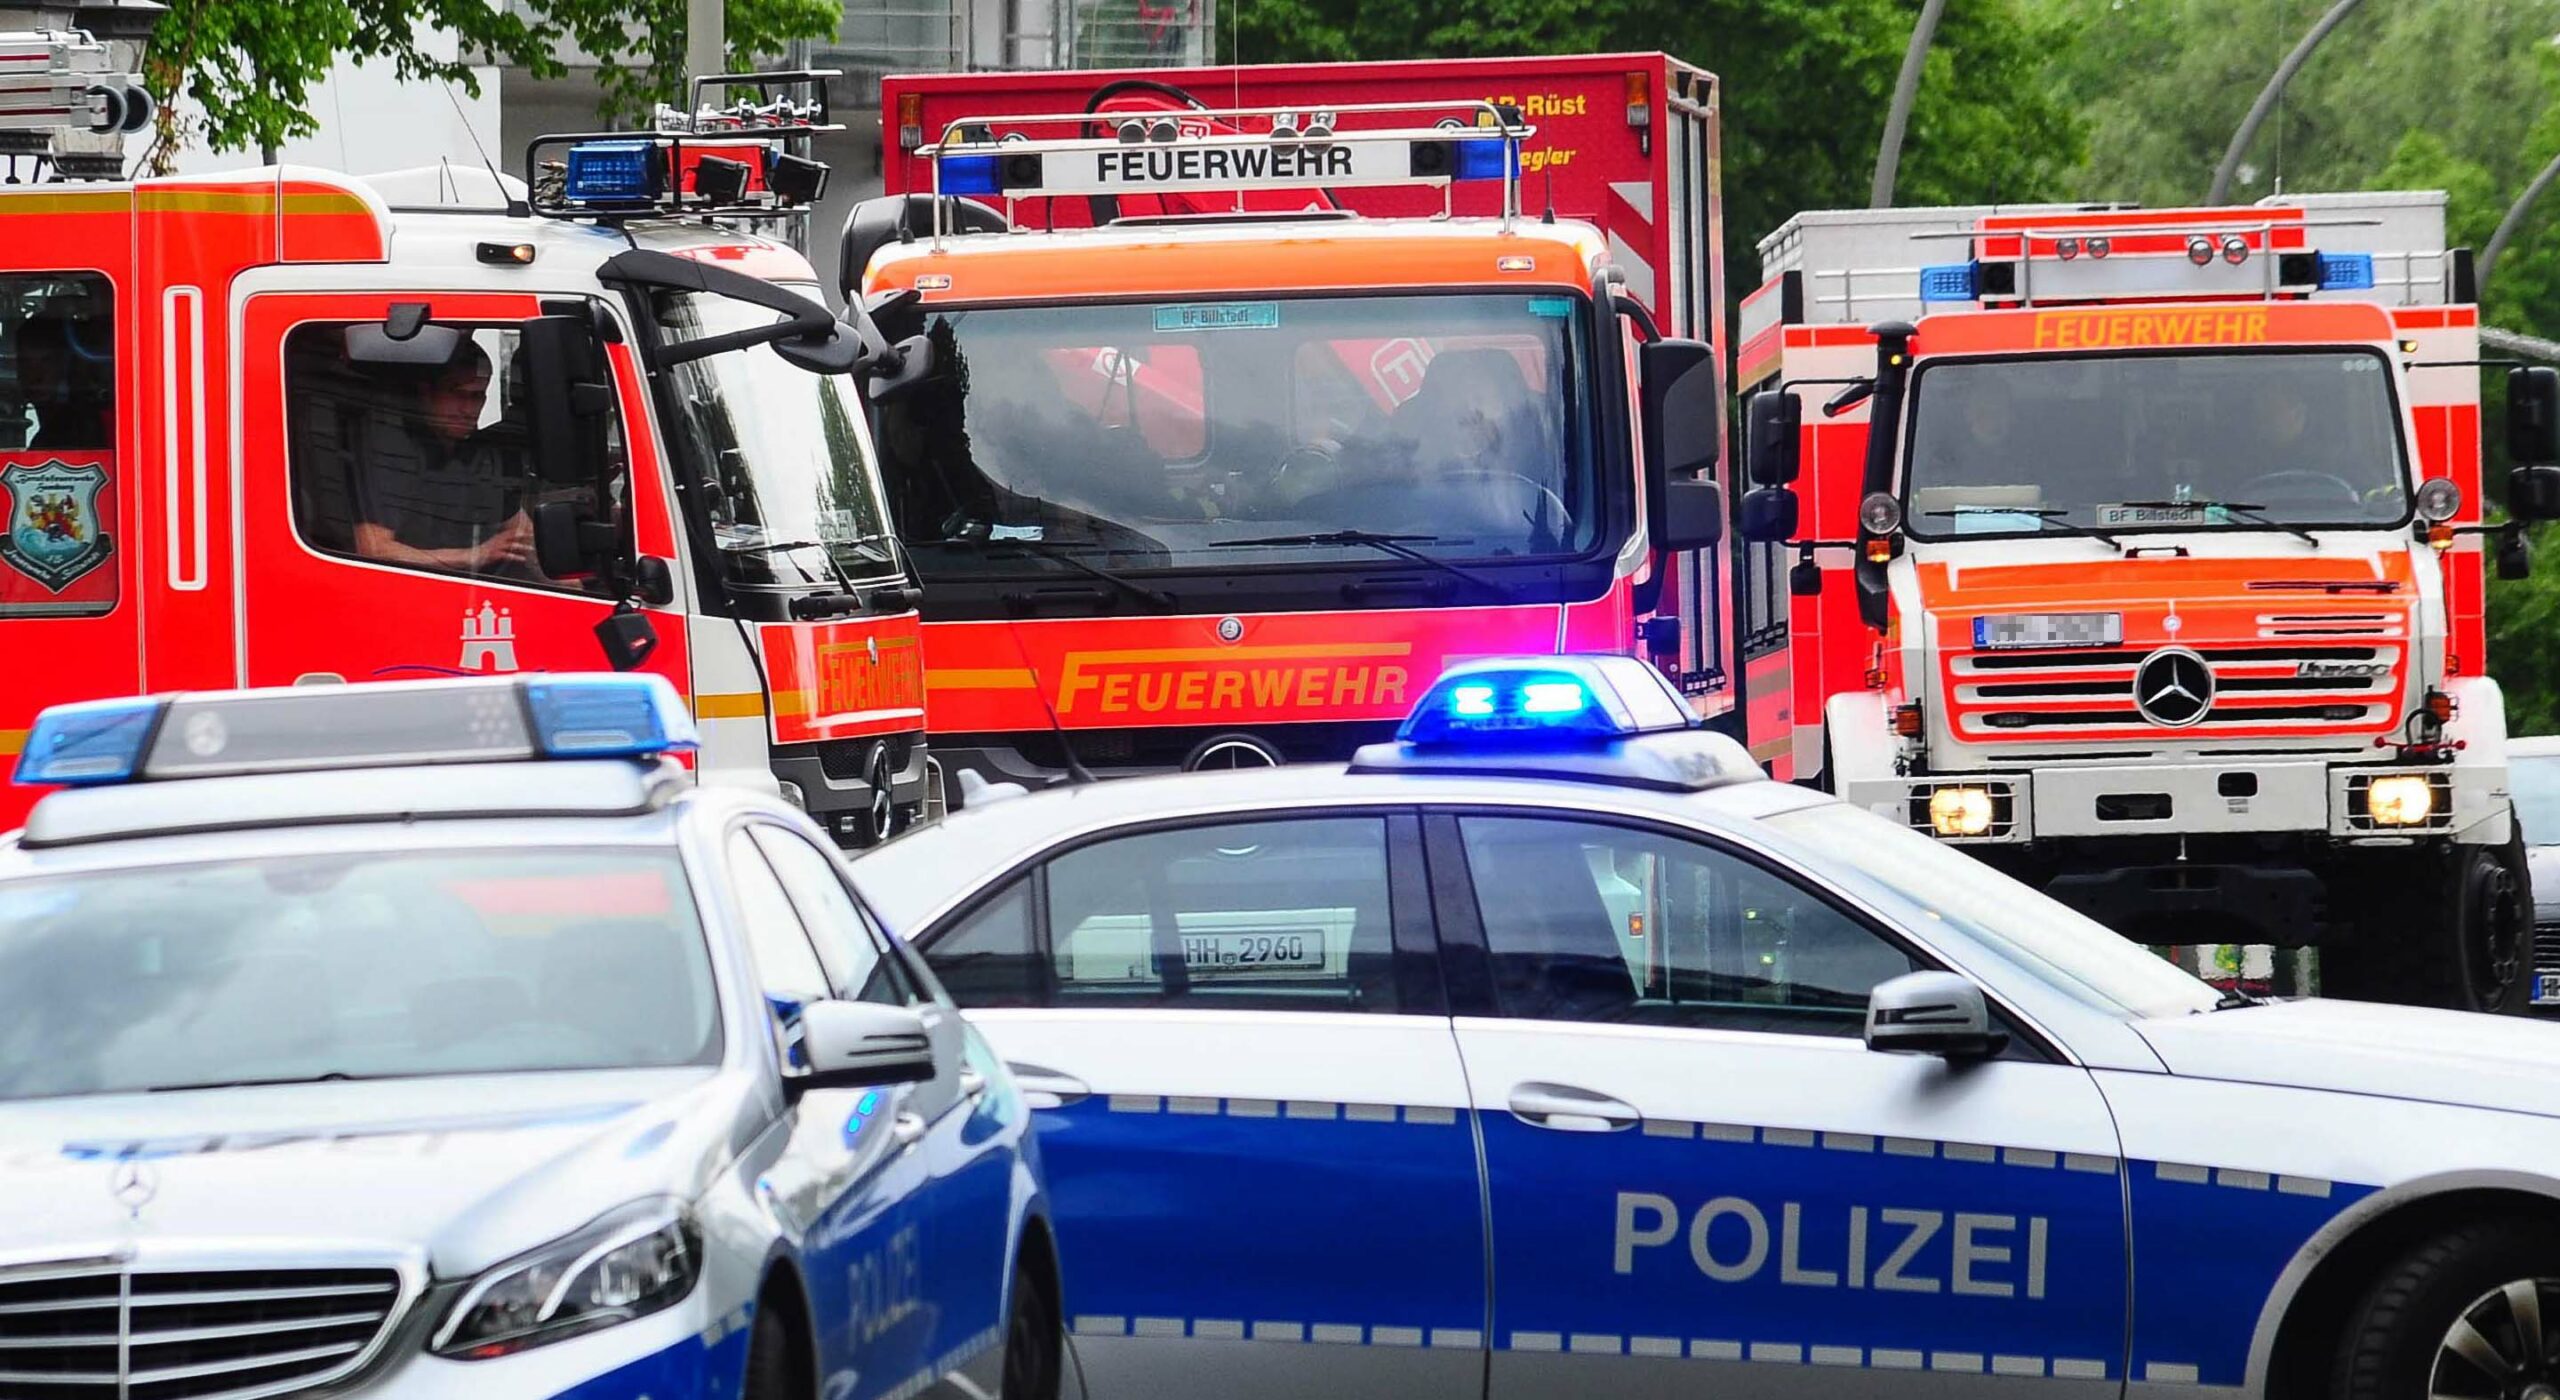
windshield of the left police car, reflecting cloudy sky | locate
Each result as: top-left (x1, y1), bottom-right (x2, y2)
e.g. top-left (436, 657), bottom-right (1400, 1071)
top-left (0, 850), bottom-right (719, 1101)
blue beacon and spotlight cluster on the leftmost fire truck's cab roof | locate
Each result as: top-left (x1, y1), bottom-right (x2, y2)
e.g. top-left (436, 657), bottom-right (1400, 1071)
top-left (525, 69), bottom-right (845, 220)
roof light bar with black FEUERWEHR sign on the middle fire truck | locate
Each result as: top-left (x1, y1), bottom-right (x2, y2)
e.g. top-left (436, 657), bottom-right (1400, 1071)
top-left (916, 102), bottom-right (1536, 235)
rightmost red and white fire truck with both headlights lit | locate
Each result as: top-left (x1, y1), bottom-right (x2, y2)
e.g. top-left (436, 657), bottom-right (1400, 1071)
top-left (1736, 195), bottom-right (2555, 1008)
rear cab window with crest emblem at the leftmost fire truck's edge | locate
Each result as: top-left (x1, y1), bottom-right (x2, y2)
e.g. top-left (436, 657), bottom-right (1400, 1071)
top-left (0, 271), bottom-right (123, 617)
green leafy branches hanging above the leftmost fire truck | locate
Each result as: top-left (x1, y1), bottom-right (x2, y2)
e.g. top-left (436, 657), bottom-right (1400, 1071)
top-left (146, 0), bottom-right (842, 169)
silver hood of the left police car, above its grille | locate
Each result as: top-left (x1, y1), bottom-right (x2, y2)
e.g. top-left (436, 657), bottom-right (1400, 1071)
top-left (0, 1067), bottom-right (763, 1277)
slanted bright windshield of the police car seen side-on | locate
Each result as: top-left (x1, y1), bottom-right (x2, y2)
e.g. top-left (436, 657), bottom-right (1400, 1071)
top-left (1766, 804), bottom-right (2222, 1016)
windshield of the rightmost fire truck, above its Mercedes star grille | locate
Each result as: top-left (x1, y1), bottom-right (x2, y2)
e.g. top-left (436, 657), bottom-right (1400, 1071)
top-left (1905, 351), bottom-right (2409, 540)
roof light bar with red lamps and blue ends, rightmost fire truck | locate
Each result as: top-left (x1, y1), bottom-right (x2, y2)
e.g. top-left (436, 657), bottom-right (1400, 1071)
top-left (1915, 215), bottom-right (2373, 305)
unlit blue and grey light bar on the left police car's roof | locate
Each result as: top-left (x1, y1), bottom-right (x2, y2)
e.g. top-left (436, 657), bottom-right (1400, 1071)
top-left (15, 676), bottom-right (701, 786)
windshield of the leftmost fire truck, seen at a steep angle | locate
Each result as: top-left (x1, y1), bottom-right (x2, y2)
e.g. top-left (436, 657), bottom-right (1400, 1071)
top-left (658, 287), bottom-right (899, 586)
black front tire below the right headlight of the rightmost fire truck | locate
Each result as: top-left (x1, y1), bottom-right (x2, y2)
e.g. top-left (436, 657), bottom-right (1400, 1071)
top-left (2319, 808), bottom-right (2534, 1016)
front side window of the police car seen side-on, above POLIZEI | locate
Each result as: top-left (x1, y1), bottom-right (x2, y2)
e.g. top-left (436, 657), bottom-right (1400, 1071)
top-left (1459, 816), bottom-right (1912, 1037)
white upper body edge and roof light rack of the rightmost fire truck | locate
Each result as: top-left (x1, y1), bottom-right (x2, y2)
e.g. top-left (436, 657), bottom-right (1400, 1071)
top-left (1746, 192), bottom-right (2470, 330)
